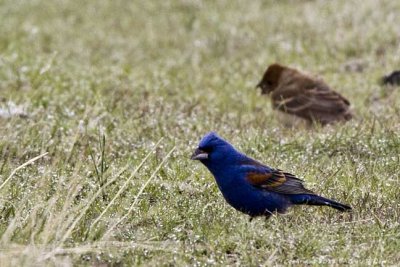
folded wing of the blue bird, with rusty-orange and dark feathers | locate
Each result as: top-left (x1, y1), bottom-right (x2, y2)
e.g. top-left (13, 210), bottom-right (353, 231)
top-left (246, 169), bottom-right (314, 195)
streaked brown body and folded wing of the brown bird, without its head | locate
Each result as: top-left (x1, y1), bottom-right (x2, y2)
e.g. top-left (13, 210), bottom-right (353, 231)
top-left (272, 78), bottom-right (352, 124)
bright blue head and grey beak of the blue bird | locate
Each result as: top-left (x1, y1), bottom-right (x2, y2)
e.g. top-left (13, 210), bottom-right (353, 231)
top-left (191, 132), bottom-right (242, 169)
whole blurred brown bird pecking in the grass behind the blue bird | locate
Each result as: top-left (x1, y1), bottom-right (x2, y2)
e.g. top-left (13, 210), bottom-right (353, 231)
top-left (256, 64), bottom-right (353, 125)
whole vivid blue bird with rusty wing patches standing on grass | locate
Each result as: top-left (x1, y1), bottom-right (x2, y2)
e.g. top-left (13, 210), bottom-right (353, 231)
top-left (191, 132), bottom-right (351, 219)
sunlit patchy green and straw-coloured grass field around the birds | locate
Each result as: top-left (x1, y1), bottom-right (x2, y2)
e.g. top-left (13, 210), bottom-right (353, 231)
top-left (0, 0), bottom-right (400, 266)
